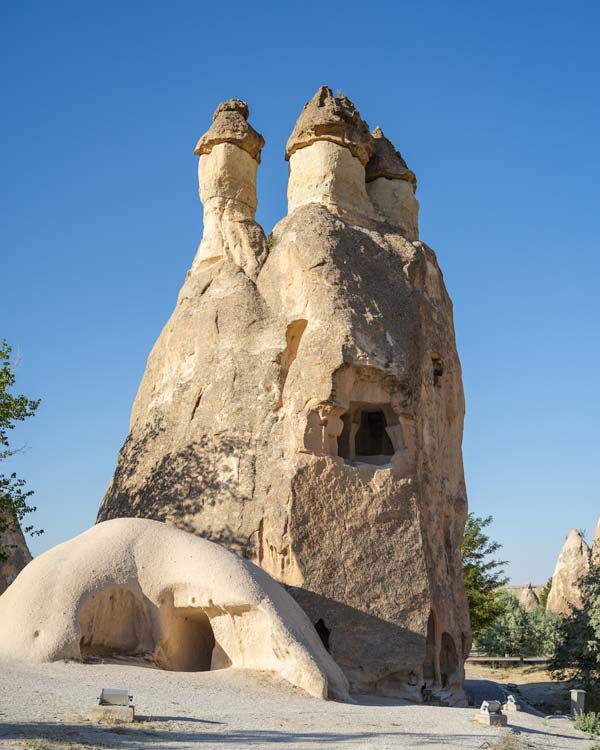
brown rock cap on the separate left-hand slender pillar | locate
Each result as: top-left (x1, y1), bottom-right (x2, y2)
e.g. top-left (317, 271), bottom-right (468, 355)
top-left (194, 99), bottom-right (265, 164)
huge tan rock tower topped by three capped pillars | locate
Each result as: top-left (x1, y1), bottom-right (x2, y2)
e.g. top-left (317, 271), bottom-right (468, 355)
top-left (98, 87), bottom-right (471, 702)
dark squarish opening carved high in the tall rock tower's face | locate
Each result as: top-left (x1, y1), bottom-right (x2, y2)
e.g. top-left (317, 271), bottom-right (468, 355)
top-left (338, 403), bottom-right (400, 464)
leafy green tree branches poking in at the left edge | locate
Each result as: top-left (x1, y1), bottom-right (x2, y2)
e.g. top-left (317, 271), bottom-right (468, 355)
top-left (0, 339), bottom-right (42, 560)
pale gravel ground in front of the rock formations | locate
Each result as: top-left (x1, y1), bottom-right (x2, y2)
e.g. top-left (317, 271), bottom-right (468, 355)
top-left (0, 662), bottom-right (594, 750)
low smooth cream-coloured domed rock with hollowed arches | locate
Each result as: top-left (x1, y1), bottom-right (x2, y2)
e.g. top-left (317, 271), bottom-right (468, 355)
top-left (0, 518), bottom-right (348, 699)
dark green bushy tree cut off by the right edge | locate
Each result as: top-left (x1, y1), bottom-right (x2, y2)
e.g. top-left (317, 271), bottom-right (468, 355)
top-left (550, 565), bottom-right (600, 692)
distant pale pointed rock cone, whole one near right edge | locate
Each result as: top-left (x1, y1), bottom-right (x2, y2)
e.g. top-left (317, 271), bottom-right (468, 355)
top-left (546, 529), bottom-right (591, 615)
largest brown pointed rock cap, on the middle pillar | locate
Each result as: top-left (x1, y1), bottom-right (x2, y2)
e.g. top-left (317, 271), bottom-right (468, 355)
top-left (285, 86), bottom-right (374, 166)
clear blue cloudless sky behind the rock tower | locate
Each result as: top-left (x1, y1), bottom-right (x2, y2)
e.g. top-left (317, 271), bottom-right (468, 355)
top-left (0, 0), bottom-right (600, 583)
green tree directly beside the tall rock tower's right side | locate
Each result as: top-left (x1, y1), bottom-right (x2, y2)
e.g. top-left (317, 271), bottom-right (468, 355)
top-left (461, 513), bottom-right (508, 641)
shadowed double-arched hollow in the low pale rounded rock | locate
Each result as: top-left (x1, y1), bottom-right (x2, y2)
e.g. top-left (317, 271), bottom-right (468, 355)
top-left (79, 586), bottom-right (215, 672)
